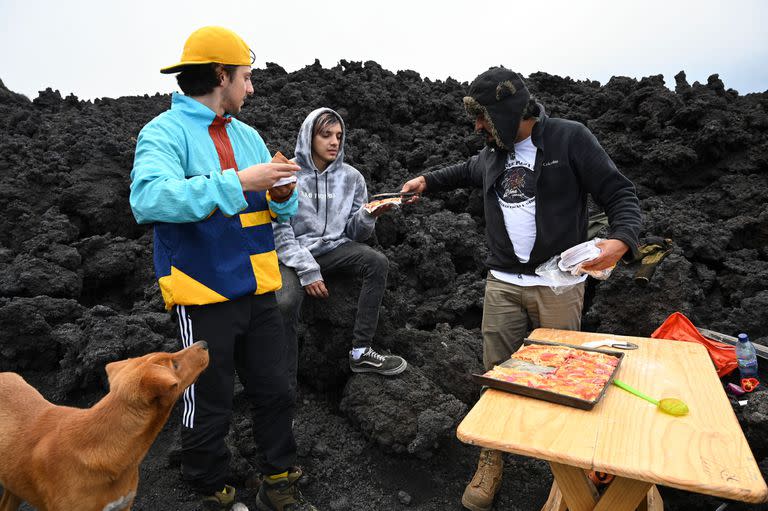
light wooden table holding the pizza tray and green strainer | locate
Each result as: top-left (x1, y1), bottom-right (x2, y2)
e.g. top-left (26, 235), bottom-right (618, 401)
top-left (457, 328), bottom-right (768, 511)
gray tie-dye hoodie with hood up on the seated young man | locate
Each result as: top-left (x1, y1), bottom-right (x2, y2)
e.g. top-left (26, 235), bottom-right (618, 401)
top-left (272, 108), bottom-right (376, 286)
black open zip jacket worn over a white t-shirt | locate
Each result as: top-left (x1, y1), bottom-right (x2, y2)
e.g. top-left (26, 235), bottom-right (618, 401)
top-left (424, 113), bottom-right (642, 275)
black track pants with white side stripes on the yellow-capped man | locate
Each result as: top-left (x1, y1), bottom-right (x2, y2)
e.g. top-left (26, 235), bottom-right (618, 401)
top-left (176, 293), bottom-right (296, 493)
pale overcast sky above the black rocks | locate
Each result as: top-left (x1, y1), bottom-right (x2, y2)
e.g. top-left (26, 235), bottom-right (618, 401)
top-left (0, 0), bottom-right (768, 99)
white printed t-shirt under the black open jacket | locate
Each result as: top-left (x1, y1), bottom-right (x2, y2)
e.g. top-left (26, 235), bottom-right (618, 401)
top-left (491, 137), bottom-right (587, 286)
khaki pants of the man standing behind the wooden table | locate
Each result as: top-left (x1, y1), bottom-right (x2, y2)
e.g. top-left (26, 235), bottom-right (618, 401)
top-left (482, 272), bottom-right (585, 369)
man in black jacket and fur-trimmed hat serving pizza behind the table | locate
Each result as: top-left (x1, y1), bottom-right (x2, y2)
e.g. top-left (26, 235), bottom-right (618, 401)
top-left (402, 67), bottom-right (641, 511)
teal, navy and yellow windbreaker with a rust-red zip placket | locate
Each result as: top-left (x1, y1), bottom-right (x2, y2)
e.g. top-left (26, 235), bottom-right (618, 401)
top-left (130, 94), bottom-right (282, 309)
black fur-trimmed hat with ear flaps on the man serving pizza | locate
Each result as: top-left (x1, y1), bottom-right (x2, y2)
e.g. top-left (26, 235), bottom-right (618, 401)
top-left (464, 67), bottom-right (531, 153)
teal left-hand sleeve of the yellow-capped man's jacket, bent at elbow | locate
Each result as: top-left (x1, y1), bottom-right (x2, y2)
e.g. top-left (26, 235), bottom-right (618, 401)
top-left (130, 123), bottom-right (248, 224)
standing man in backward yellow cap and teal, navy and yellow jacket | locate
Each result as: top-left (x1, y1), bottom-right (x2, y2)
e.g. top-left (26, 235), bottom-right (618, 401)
top-left (130, 27), bottom-right (316, 511)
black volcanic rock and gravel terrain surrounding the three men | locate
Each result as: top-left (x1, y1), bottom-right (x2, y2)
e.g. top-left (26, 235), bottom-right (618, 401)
top-left (0, 61), bottom-right (768, 511)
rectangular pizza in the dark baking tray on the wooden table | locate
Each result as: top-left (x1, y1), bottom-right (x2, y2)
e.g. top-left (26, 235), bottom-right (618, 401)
top-left (484, 344), bottom-right (619, 401)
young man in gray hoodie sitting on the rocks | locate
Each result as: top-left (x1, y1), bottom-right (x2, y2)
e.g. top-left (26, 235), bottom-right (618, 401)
top-left (273, 108), bottom-right (407, 383)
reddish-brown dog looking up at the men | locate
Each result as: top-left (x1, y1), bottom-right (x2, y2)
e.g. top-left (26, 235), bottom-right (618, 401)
top-left (0, 341), bottom-right (208, 511)
